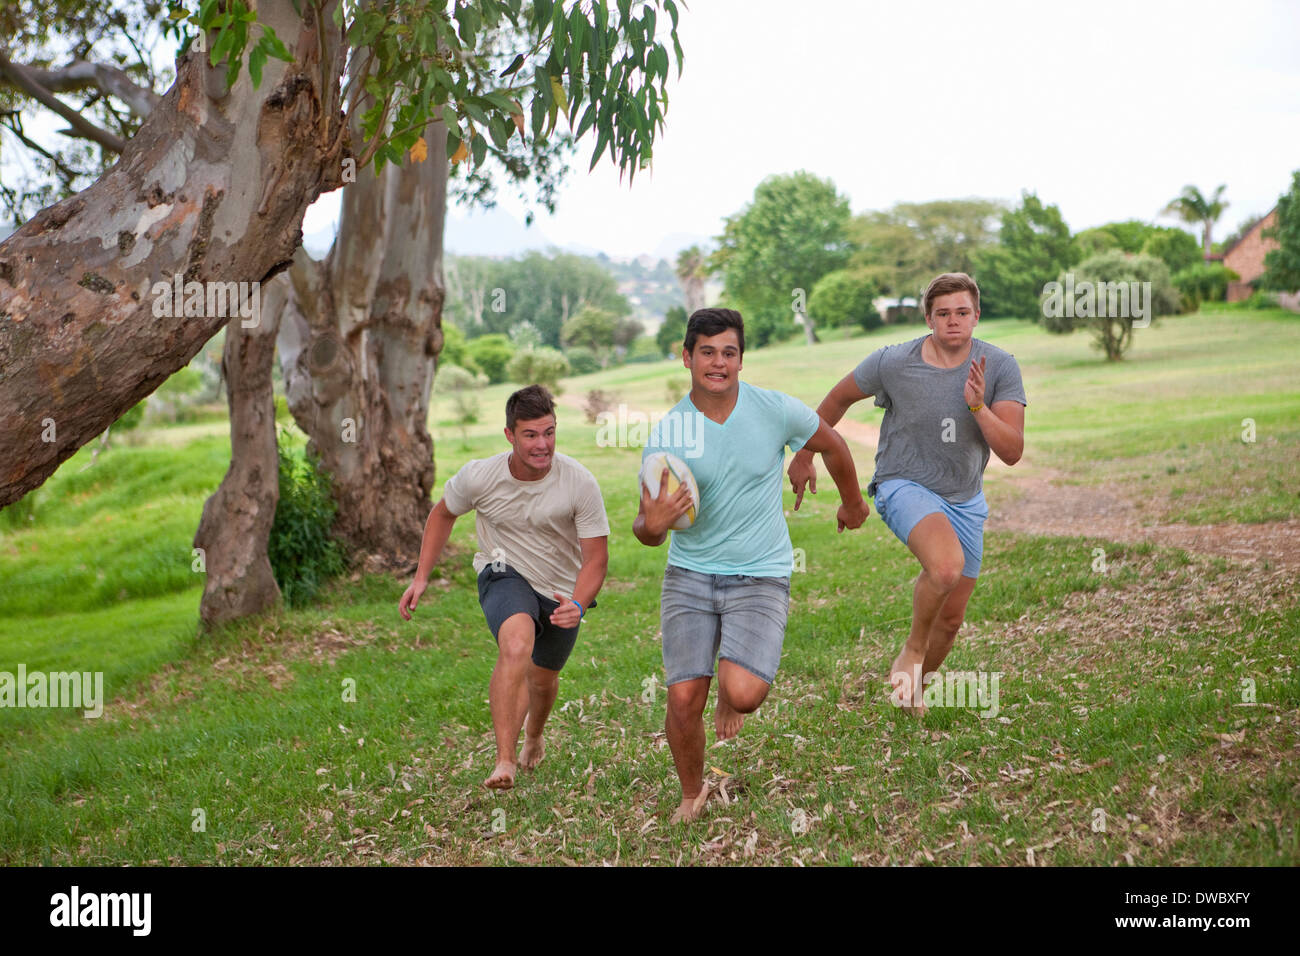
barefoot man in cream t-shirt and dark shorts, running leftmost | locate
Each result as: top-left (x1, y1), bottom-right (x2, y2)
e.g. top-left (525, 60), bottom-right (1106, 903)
top-left (398, 385), bottom-right (610, 790)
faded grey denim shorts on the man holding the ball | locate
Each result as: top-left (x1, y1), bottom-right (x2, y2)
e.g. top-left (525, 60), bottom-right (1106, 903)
top-left (659, 564), bottom-right (790, 684)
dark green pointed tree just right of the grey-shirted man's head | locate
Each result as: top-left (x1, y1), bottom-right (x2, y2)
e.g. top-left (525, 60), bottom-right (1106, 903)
top-left (971, 193), bottom-right (1075, 321)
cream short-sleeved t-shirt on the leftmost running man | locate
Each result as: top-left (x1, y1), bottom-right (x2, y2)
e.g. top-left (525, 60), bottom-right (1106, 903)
top-left (442, 451), bottom-right (610, 598)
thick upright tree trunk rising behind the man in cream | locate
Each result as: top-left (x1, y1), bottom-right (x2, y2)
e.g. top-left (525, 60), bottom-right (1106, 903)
top-left (280, 122), bottom-right (447, 570)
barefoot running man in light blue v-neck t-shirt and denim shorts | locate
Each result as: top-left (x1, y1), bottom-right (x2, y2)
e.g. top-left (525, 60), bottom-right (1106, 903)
top-left (632, 308), bottom-right (868, 822)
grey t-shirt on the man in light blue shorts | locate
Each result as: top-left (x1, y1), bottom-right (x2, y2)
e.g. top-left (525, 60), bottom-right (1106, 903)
top-left (853, 336), bottom-right (1028, 505)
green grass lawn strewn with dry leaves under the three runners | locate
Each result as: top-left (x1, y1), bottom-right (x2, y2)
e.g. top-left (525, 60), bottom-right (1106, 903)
top-left (0, 312), bottom-right (1300, 865)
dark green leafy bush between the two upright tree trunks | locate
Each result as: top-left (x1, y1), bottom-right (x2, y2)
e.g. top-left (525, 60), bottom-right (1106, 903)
top-left (267, 432), bottom-right (347, 607)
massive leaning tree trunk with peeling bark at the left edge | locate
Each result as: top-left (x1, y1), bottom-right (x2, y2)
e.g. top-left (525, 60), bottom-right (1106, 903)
top-left (0, 0), bottom-right (347, 507)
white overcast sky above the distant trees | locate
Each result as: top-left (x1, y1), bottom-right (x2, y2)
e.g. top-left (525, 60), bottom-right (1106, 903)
top-left (384, 0), bottom-right (1300, 255)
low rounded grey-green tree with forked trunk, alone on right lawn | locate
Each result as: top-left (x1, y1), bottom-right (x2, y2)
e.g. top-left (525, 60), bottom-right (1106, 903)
top-left (1040, 248), bottom-right (1179, 362)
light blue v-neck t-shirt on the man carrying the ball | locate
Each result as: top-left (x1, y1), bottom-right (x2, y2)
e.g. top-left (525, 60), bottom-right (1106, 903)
top-left (641, 382), bottom-right (820, 578)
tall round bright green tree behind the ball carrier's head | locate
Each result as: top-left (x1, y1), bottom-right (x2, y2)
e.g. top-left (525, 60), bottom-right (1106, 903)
top-left (710, 172), bottom-right (849, 347)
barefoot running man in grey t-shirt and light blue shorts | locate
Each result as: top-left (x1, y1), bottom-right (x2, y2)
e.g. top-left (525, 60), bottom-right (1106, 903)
top-left (789, 272), bottom-right (1027, 714)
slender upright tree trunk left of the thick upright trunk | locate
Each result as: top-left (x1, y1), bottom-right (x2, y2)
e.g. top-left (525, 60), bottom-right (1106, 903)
top-left (194, 303), bottom-right (283, 624)
